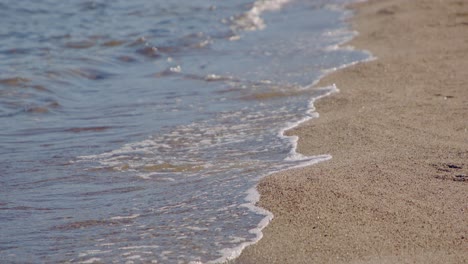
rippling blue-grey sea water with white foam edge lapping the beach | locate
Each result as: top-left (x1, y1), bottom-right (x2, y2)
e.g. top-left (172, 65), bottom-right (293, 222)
top-left (0, 0), bottom-right (368, 263)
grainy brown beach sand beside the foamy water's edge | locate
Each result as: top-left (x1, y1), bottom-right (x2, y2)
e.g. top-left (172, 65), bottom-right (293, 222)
top-left (235, 0), bottom-right (468, 263)
